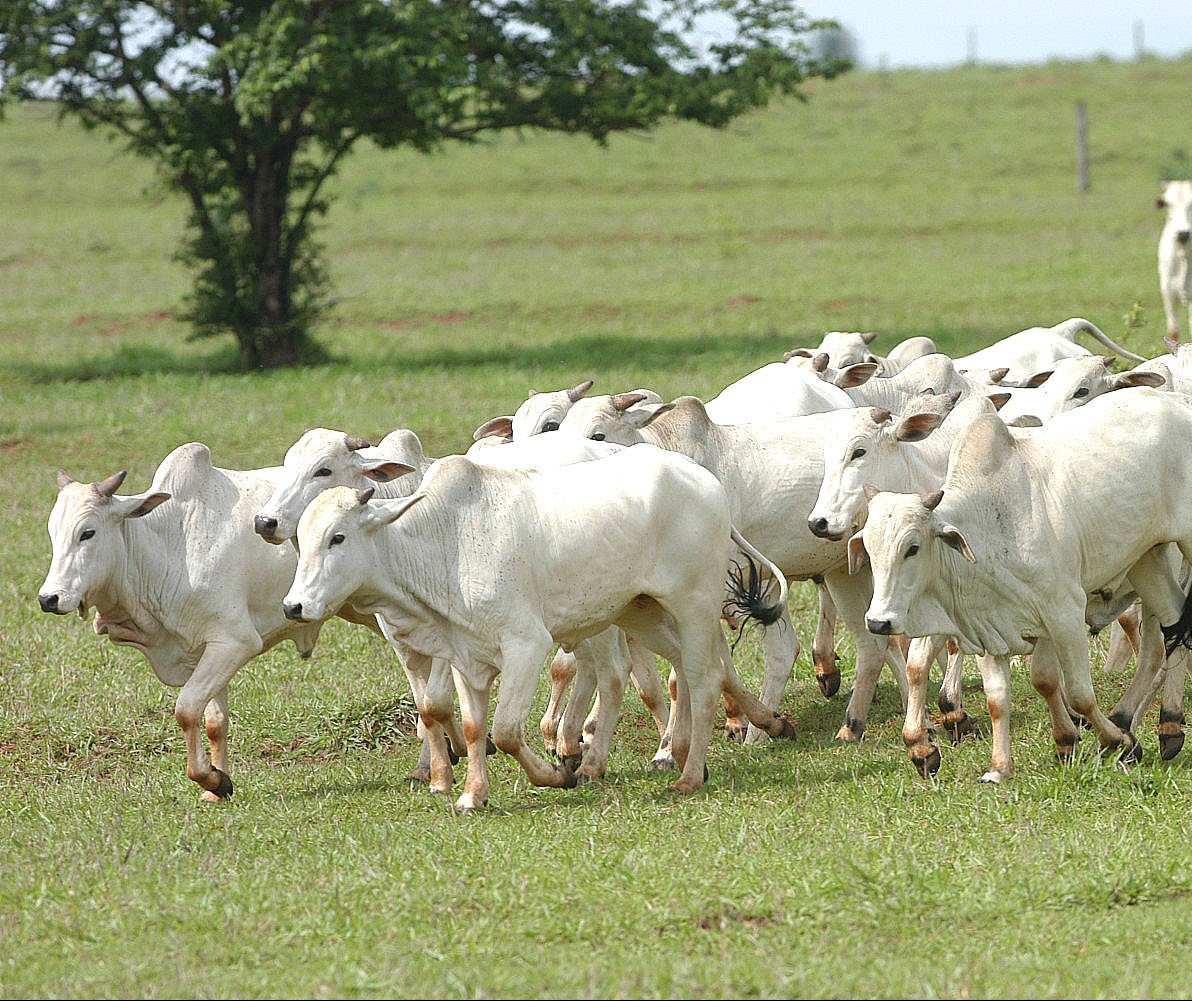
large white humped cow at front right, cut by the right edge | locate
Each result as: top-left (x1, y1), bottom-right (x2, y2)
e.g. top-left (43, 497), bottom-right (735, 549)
top-left (849, 388), bottom-right (1192, 782)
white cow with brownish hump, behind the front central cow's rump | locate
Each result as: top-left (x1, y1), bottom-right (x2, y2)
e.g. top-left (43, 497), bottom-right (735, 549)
top-left (563, 394), bottom-right (905, 741)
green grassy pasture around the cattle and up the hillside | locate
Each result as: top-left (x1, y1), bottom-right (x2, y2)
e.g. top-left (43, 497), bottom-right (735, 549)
top-left (0, 61), bottom-right (1192, 997)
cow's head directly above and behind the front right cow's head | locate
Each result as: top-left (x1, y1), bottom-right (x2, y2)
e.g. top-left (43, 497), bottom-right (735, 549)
top-left (807, 397), bottom-right (956, 540)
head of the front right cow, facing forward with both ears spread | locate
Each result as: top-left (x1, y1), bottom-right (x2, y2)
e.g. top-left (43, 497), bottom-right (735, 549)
top-left (849, 486), bottom-right (976, 636)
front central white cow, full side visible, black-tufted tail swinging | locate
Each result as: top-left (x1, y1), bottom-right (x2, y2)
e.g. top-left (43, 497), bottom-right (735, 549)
top-left (285, 448), bottom-right (790, 810)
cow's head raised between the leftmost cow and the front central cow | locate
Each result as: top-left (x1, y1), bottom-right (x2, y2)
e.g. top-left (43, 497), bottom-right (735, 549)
top-left (253, 428), bottom-right (415, 545)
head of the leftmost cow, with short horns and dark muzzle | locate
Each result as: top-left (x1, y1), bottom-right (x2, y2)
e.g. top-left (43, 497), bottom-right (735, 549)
top-left (37, 470), bottom-right (169, 615)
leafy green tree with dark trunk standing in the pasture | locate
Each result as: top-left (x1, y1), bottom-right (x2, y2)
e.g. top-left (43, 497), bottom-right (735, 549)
top-left (0, 0), bottom-right (842, 368)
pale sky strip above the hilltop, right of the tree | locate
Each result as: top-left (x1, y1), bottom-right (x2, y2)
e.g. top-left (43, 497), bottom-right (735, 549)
top-left (800, 0), bottom-right (1192, 69)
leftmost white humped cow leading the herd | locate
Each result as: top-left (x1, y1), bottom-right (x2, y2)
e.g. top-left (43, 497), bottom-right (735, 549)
top-left (38, 442), bottom-right (319, 801)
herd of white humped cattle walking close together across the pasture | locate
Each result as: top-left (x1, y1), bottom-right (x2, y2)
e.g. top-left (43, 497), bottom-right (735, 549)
top-left (38, 307), bottom-right (1192, 810)
